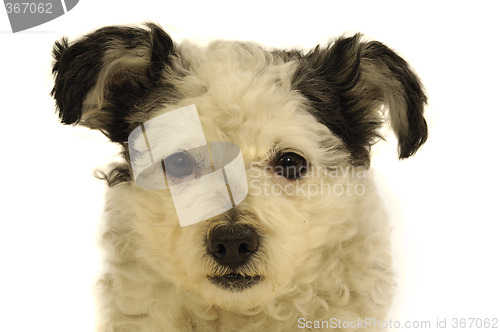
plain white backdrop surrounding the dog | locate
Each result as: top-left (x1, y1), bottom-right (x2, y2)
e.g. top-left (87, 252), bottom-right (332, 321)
top-left (0, 0), bottom-right (500, 332)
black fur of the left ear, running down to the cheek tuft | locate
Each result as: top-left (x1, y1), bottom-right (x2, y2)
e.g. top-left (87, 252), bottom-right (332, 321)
top-left (51, 23), bottom-right (185, 186)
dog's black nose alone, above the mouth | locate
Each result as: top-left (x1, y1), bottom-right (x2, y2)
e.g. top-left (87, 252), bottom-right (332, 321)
top-left (207, 224), bottom-right (259, 269)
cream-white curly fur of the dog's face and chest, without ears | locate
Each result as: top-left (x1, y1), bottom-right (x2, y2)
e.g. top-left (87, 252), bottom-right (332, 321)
top-left (94, 42), bottom-right (394, 332)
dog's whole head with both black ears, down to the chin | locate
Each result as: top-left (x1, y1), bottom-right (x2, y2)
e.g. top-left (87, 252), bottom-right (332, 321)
top-left (52, 24), bottom-right (427, 310)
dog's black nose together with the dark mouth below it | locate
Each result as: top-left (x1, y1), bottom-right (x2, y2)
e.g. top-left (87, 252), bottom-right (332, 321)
top-left (207, 224), bottom-right (262, 291)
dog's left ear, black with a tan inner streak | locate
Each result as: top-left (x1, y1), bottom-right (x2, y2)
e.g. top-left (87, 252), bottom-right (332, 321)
top-left (51, 23), bottom-right (174, 142)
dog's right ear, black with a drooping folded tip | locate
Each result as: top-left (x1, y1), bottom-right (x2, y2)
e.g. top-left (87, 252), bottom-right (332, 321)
top-left (296, 34), bottom-right (427, 165)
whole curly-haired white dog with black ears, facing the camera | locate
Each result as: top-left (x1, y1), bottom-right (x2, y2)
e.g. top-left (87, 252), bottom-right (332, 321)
top-left (51, 23), bottom-right (428, 332)
